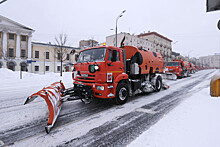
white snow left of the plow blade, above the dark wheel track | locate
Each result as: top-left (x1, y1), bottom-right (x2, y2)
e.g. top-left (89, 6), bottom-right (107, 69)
top-left (0, 68), bottom-right (72, 131)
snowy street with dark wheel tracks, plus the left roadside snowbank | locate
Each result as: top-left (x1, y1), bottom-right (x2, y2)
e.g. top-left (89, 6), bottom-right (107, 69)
top-left (0, 69), bottom-right (217, 146)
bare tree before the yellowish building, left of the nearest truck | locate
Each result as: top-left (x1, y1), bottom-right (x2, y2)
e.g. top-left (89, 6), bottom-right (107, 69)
top-left (55, 34), bottom-right (68, 76)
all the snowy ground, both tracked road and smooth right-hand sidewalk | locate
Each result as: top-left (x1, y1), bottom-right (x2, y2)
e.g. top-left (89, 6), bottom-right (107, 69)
top-left (0, 69), bottom-right (220, 147)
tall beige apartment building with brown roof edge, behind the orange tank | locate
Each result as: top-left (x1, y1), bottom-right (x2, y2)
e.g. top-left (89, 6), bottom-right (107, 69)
top-left (138, 32), bottom-right (172, 61)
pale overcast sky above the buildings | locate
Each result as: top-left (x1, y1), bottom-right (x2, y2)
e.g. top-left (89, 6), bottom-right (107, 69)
top-left (0, 0), bottom-right (220, 57)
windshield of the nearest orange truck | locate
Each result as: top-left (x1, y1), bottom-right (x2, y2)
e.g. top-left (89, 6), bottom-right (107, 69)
top-left (77, 48), bottom-right (106, 63)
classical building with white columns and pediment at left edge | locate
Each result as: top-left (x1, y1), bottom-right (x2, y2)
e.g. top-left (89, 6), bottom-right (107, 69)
top-left (0, 15), bottom-right (34, 71)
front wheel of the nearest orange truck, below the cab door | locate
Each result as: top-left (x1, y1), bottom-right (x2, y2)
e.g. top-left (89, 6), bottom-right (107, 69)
top-left (115, 83), bottom-right (129, 105)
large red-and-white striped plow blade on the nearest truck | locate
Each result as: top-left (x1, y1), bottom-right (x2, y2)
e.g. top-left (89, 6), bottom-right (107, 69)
top-left (24, 81), bottom-right (65, 133)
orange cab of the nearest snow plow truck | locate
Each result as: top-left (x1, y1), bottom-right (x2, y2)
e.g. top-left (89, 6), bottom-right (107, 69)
top-left (73, 46), bottom-right (128, 103)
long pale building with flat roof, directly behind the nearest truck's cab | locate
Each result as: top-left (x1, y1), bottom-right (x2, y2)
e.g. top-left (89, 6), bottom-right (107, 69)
top-left (106, 32), bottom-right (153, 50)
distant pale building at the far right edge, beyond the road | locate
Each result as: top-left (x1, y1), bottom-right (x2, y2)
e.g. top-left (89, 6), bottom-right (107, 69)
top-left (199, 53), bottom-right (220, 68)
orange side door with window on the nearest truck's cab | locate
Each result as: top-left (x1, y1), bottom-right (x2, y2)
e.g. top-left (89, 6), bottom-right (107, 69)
top-left (107, 49), bottom-right (124, 82)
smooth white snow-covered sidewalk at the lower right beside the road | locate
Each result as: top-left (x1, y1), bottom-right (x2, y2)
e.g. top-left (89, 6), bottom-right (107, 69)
top-left (129, 73), bottom-right (220, 147)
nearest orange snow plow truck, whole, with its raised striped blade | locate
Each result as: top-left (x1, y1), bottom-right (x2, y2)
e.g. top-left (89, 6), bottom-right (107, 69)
top-left (25, 46), bottom-right (169, 133)
